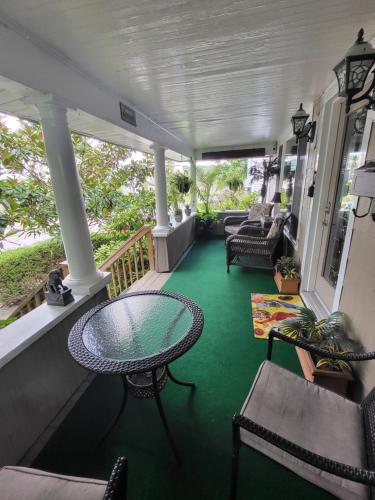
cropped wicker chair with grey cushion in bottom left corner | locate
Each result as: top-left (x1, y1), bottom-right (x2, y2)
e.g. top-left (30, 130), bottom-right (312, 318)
top-left (0, 457), bottom-right (128, 500)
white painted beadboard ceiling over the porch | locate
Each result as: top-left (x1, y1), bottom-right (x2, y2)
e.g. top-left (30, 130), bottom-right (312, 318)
top-left (0, 0), bottom-right (375, 149)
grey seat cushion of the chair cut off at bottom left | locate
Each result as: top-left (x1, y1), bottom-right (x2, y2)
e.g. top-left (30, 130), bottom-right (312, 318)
top-left (0, 466), bottom-right (107, 500)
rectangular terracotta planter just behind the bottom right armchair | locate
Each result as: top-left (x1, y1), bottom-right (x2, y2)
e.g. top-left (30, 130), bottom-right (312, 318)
top-left (296, 347), bottom-right (353, 396)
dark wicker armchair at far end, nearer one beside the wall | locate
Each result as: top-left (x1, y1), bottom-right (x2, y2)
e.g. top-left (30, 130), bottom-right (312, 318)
top-left (226, 217), bottom-right (289, 273)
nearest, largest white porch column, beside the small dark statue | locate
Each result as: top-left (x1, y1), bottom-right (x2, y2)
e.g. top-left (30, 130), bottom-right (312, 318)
top-left (35, 96), bottom-right (104, 293)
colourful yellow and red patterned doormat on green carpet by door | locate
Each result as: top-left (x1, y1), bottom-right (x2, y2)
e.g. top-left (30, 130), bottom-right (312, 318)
top-left (251, 293), bottom-right (304, 339)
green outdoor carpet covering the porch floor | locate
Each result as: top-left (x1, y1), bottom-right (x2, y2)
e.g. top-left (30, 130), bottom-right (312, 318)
top-left (34, 240), bottom-right (333, 500)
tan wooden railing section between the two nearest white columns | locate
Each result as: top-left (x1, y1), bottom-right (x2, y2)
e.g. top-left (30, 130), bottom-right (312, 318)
top-left (100, 226), bottom-right (155, 298)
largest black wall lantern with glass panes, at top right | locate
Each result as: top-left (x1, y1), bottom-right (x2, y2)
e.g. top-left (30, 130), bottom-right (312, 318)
top-left (333, 28), bottom-right (375, 113)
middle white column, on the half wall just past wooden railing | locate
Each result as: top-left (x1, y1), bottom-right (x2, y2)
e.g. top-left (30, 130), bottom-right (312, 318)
top-left (152, 144), bottom-right (170, 236)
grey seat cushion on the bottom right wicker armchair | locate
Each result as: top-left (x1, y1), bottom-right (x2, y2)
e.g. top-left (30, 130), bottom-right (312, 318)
top-left (241, 361), bottom-right (370, 500)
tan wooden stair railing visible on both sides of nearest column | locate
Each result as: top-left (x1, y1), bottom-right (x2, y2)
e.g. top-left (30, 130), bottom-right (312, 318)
top-left (1, 226), bottom-right (155, 319)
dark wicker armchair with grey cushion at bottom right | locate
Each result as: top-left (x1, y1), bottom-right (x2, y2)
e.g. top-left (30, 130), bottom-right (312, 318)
top-left (231, 330), bottom-right (375, 500)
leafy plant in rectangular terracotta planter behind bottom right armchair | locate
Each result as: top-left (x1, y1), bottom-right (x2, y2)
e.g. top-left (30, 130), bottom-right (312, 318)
top-left (279, 307), bottom-right (354, 396)
